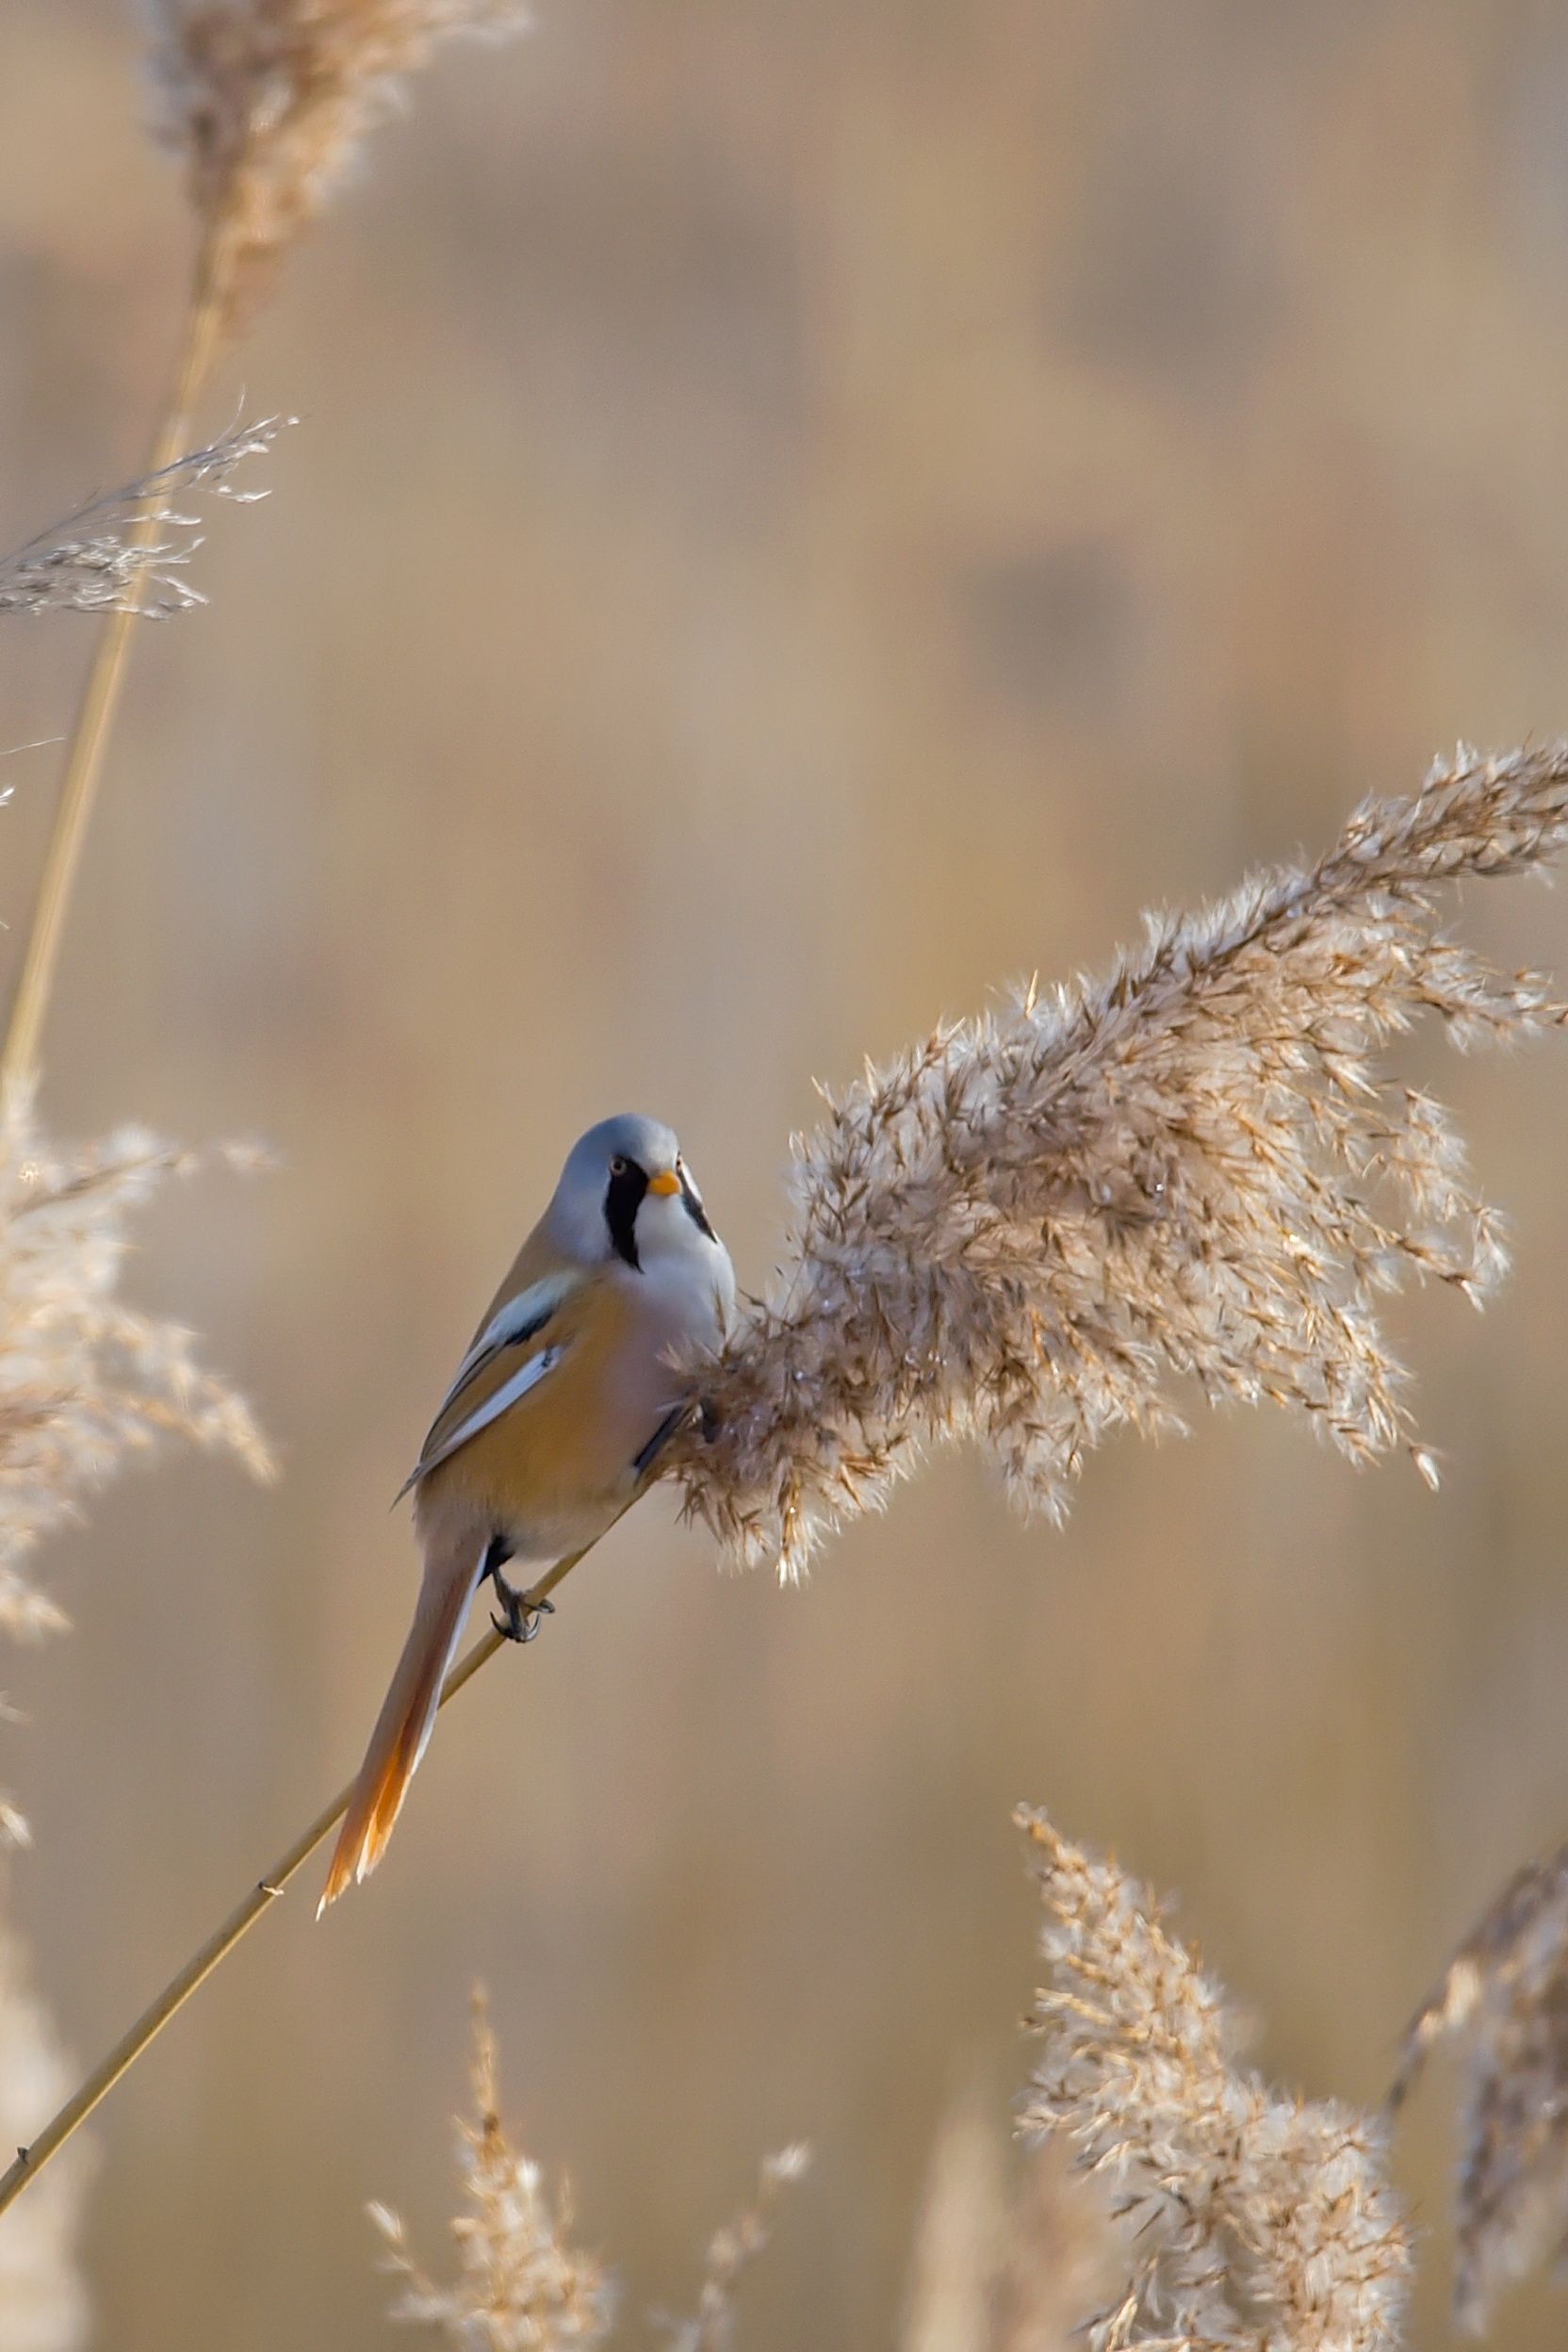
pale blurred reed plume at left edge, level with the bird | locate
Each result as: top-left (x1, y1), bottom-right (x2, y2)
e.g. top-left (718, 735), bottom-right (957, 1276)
top-left (0, 1101), bottom-right (272, 1674)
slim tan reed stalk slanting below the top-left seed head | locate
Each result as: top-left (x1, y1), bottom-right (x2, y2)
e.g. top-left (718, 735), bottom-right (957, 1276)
top-left (0, 219), bottom-right (237, 1096)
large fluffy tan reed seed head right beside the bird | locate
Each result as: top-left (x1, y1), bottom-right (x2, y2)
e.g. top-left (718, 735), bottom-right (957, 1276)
top-left (675, 743), bottom-right (1568, 1574)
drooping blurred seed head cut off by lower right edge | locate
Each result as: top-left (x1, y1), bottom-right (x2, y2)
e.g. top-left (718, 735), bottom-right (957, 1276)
top-left (1389, 1846), bottom-right (1568, 2333)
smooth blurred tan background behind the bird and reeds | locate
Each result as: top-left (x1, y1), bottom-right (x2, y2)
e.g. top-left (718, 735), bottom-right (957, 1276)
top-left (0, 0), bottom-right (1568, 2352)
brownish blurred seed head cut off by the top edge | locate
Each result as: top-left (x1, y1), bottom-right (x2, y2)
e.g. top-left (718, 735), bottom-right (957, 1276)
top-left (143, 0), bottom-right (527, 318)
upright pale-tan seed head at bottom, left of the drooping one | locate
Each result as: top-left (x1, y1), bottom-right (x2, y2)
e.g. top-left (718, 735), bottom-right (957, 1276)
top-left (1016, 1808), bottom-right (1411, 2352)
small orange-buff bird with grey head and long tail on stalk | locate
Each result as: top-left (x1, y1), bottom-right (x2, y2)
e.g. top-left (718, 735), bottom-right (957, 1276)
top-left (318, 1115), bottom-right (736, 1919)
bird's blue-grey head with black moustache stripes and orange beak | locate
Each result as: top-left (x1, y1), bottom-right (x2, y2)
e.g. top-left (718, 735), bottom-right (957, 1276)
top-left (546, 1110), bottom-right (722, 1272)
